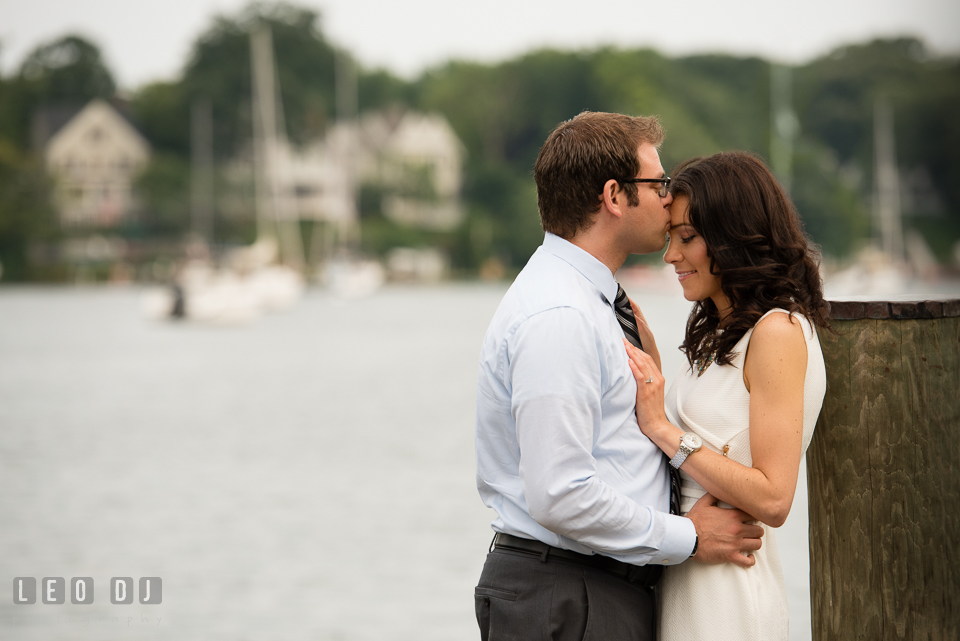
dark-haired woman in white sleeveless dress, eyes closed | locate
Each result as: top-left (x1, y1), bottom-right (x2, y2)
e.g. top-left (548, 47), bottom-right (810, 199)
top-left (628, 152), bottom-right (827, 641)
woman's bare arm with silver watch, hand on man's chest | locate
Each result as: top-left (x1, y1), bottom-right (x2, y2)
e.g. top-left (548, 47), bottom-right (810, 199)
top-left (628, 313), bottom-right (807, 527)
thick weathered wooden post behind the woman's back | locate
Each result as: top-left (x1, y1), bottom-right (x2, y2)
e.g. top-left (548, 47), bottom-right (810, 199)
top-left (807, 300), bottom-right (960, 641)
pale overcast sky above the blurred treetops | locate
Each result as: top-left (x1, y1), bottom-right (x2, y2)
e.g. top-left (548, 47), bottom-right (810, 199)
top-left (0, 0), bottom-right (960, 89)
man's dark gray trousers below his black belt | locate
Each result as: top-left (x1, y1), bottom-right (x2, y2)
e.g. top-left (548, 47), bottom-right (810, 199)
top-left (474, 548), bottom-right (656, 641)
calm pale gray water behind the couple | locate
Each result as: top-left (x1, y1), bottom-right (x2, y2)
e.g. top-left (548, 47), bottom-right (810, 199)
top-left (0, 284), bottom-right (810, 641)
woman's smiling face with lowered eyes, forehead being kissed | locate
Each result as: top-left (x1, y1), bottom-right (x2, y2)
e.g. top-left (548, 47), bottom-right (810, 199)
top-left (663, 195), bottom-right (730, 312)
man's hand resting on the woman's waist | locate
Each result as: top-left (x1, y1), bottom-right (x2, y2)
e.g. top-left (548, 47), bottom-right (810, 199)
top-left (687, 494), bottom-right (763, 568)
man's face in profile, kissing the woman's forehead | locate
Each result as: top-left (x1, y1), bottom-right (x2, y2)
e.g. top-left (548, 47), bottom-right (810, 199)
top-left (623, 142), bottom-right (672, 254)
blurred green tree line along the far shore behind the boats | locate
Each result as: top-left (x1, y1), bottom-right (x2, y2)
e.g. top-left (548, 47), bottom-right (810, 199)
top-left (0, 4), bottom-right (960, 280)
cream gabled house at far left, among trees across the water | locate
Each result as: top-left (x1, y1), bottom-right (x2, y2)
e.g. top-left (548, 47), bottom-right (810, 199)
top-left (45, 99), bottom-right (150, 227)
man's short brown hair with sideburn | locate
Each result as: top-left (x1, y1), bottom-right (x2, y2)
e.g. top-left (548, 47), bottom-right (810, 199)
top-left (533, 111), bottom-right (664, 240)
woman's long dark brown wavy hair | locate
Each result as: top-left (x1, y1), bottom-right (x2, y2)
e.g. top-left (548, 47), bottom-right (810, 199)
top-left (670, 151), bottom-right (829, 367)
